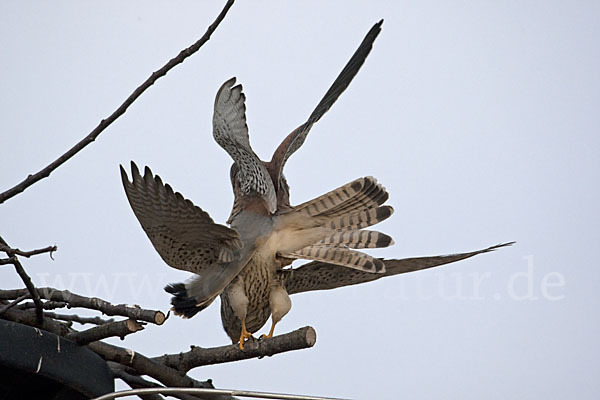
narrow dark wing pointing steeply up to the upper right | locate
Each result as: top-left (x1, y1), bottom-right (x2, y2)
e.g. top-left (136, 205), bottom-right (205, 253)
top-left (271, 20), bottom-right (383, 182)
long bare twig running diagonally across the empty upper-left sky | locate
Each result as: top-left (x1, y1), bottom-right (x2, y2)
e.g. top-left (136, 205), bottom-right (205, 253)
top-left (0, 0), bottom-right (234, 204)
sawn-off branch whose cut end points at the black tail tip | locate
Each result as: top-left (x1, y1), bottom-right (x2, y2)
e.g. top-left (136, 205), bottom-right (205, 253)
top-left (0, 287), bottom-right (166, 325)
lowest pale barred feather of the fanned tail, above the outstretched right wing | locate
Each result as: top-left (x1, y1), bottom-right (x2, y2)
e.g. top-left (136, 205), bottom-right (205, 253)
top-left (284, 245), bottom-right (385, 273)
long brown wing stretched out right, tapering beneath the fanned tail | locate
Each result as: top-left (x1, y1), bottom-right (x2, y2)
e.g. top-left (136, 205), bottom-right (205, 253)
top-left (281, 242), bottom-right (514, 294)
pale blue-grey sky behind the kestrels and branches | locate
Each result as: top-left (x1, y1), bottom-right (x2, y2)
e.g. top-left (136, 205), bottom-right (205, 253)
top-left (0, 1), bottom-right (600, 400)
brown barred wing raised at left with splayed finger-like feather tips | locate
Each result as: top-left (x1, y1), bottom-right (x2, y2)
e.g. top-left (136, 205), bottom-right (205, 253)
top-left (121, 161), bottom-right (242, 275)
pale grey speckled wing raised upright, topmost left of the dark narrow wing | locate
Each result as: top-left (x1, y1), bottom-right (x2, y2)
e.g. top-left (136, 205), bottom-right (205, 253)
top-left (213, 78), bottom-right (277, 213)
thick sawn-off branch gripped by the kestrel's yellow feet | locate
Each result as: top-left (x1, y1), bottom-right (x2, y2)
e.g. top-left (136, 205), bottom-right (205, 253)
top-left (152, 326), bottom-right (317, 372)
